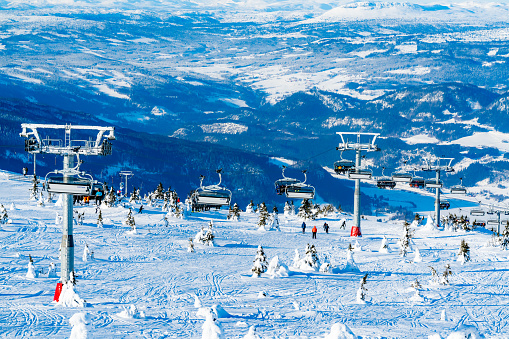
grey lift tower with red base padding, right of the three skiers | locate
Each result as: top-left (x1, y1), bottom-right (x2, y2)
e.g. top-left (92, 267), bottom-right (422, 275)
top-left (336, 132), bottom-right (380, 236)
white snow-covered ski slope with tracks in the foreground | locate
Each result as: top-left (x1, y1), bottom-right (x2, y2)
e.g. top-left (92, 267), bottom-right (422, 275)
top-left (0, 179), bottom-right (509, 339)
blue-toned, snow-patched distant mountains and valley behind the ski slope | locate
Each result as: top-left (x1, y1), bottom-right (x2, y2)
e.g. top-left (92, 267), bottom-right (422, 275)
top-left (0, 7), bottom-right (509, 210)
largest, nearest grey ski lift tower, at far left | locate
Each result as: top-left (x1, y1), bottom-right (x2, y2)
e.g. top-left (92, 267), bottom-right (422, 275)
top-left (20, 124), bottom-right (115, 284)
